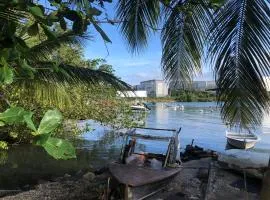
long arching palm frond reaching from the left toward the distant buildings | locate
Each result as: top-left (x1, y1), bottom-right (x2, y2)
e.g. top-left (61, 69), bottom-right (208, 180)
top-left (23, 62), bottom-right (130, 90)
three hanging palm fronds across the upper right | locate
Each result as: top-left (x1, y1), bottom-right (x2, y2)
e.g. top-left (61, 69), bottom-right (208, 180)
top-left (117, 0), bottom-right (270, 127)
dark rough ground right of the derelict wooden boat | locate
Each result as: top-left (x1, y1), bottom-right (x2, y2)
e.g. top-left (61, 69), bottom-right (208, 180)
top-left (151, 158), bottom-right (261, 200)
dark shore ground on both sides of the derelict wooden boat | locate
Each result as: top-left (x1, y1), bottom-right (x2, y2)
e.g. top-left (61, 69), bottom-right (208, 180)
top-left (2, 158), bottom-right (261, 200)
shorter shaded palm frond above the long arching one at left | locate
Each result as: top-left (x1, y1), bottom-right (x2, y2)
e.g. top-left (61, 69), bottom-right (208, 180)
top-left (25, 31), bottom-right (91, 61)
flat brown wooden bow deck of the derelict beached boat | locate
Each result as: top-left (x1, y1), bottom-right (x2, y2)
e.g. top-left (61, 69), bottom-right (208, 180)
top-left (109, 163), bottom-right (181, 187)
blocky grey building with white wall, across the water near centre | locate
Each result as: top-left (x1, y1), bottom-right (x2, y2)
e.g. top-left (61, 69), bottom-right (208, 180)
top-left (134, 80), bottom-right (168, 97)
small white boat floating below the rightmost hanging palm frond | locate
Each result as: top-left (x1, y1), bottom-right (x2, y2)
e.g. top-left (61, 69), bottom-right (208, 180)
top-left (226, 131), bottom-right (260, 149)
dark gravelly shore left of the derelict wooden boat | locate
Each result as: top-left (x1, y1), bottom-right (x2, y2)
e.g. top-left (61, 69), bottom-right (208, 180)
top-left (0, 169), bottom-right (108, 200)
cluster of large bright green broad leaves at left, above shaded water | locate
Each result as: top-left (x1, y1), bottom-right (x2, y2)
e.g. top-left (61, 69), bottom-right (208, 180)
top-left (0, 107), bottom-right (76, 159)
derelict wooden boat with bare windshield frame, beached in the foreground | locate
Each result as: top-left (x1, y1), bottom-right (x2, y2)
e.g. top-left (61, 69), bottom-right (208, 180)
top-left (109, 128), bottom-right (181, 200)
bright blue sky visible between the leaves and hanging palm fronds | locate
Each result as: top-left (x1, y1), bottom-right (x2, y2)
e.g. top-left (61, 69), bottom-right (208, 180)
top-left (42, 0), bottom-right (213, 85)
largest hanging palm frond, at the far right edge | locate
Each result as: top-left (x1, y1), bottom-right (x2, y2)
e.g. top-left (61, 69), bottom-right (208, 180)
top-left (209, 0), bottom-right (270, 128)
